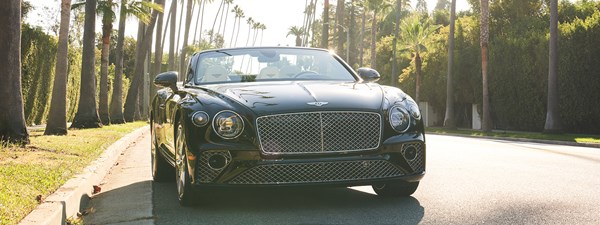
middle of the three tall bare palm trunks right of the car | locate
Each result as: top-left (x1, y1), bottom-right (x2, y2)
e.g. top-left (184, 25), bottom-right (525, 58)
top-left (479, 0), bottom-right (492, 132)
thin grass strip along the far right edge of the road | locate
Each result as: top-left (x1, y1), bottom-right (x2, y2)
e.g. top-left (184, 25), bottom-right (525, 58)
top-left (425, 127), bottom-right (600, 144)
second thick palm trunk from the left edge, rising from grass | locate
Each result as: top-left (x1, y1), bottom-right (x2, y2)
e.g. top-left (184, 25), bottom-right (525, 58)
top-left (44, 0), bottom-right (71, 135)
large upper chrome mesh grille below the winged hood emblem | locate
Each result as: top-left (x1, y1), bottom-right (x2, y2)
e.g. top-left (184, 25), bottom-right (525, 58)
top-left (256, 112), bottom-right (382, 154)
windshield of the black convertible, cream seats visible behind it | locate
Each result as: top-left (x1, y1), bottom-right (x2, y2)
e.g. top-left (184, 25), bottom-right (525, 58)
top-left (193, 48), bottom-right (356, 84)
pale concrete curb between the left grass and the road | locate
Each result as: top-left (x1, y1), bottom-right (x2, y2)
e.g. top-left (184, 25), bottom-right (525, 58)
top-left (19, 126), bottom-right (150, 225)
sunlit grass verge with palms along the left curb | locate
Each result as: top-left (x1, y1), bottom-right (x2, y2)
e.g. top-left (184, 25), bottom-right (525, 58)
top-left (0, 122), bottom-right (147, 224)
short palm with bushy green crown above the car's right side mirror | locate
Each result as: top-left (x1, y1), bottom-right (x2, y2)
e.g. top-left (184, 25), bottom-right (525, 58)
top-left (400, 15), bottom-right (437, 102)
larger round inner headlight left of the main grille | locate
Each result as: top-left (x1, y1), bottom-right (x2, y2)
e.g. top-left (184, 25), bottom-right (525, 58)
top-left (213, 110), bottom-right (244, 139)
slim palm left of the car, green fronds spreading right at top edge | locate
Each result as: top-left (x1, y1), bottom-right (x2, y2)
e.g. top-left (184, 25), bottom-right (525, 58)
top-left (110, 0), bottom-right (160, 124)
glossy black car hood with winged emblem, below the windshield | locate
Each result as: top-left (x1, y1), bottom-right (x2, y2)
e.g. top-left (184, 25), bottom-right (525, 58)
top-left (202, 81), bottom-right (383, 116)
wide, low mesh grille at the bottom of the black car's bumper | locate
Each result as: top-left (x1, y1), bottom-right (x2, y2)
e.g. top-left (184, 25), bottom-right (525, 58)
top-left (229, 160), bottom-right (406, 184)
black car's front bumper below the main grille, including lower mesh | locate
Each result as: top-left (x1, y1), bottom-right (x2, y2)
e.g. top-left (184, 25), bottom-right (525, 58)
top-left (190, 135), bottom-right (426, 186)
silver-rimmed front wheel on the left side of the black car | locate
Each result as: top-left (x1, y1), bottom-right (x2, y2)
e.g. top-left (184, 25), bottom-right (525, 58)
top-left (175, 120), bottom-right (196, 206)
